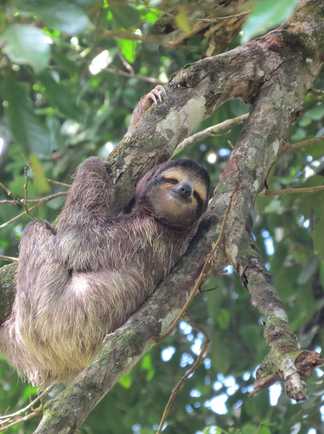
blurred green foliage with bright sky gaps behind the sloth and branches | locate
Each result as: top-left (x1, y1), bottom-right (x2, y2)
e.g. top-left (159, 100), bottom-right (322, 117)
top-left (0, 0), bottom-right (324, 434)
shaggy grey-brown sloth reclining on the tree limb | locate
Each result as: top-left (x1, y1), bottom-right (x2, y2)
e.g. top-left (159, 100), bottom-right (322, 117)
top-left (0, 86), bottom-right (209, 387)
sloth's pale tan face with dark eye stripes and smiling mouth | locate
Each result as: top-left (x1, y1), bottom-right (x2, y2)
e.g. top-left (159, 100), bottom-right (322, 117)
top-left (145, 166), bottom-right (208, 228)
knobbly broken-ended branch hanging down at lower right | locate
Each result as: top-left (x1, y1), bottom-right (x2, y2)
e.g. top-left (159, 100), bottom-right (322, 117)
top-left (241, 236), bottom-right (322, 401)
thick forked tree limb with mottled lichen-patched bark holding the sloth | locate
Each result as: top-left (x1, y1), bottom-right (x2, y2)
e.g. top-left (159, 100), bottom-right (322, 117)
top-left (0, 0), bottom-right (324, 434)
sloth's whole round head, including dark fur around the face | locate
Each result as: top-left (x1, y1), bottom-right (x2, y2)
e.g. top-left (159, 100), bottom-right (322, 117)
top-left (135, 159), bottom-right (209, 229)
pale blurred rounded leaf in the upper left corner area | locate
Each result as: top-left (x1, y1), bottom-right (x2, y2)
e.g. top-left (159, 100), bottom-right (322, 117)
top-left (0, 24), bottom-right (51, 72)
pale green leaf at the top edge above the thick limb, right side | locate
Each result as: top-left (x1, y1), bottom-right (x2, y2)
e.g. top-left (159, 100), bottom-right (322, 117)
top-left (241, 0), bottom-right (298, 44)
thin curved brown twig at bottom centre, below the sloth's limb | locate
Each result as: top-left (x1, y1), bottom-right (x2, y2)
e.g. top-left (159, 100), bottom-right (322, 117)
top-left (156, 326), bottom-right (209, 434)
